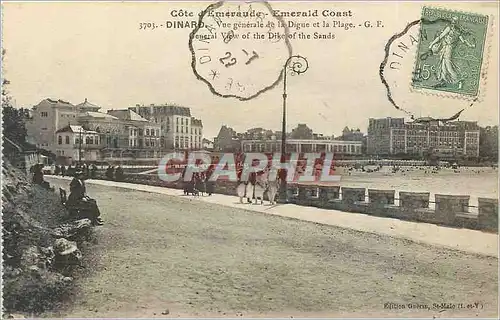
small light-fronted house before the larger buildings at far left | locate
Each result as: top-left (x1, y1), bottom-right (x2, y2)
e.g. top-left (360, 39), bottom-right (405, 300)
top-left (55, 125), bottom-right (101, 164)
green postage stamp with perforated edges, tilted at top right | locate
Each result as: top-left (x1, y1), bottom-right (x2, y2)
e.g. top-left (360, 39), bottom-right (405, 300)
top-left (412, 7), bottom-right (488, 97)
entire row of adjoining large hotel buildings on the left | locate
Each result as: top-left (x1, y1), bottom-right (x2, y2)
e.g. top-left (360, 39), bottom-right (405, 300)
top-left (26, 99), bottom-right (203, 163)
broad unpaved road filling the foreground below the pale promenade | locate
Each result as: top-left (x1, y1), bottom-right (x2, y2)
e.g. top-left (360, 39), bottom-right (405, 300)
top-left (48, 179), bottom-right (498, 318)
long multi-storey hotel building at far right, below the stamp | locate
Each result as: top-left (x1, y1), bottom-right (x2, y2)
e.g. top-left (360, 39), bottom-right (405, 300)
top-left (367, 118), bottom-right (479, 158)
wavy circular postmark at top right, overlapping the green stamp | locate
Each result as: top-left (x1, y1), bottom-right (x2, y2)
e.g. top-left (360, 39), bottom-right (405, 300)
top-left (379, 8), bottom-right (485, 121)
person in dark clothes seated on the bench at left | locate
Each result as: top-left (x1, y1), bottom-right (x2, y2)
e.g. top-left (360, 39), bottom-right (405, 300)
top-left (68, 170), bottom-right (103, 225)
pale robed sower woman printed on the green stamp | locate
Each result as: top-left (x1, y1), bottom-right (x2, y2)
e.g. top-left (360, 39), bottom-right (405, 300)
top-left (429, 17), bottom-right (475, 89)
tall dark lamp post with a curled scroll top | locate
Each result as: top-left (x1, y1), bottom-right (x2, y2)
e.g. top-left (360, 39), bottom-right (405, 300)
top-left (280, 56), bottom-right (309, 203)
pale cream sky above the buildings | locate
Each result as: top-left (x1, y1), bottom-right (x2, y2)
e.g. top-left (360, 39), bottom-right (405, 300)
top-left (2, 2), bottom-right (499, 139)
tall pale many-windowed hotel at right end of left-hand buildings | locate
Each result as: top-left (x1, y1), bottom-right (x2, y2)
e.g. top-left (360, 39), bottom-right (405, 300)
top-left (129, 104), bottom-right (203, 150)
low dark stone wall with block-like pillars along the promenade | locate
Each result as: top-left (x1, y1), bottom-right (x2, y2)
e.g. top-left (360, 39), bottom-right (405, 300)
top-left (92, 174), bottom-right (498, 232)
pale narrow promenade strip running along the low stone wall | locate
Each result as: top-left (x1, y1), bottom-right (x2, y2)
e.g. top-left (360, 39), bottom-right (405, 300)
top-left (47, 176), bottom-right (498, 257)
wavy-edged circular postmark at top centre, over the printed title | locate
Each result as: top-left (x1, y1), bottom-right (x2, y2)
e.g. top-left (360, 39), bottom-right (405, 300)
top-left (189, 2), bottom-right (292, 101)
